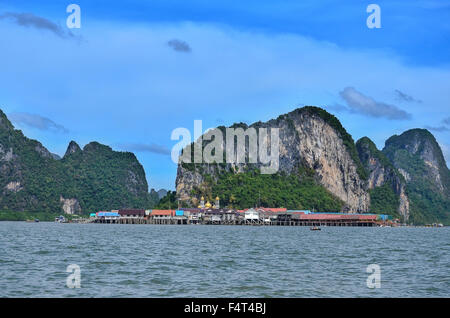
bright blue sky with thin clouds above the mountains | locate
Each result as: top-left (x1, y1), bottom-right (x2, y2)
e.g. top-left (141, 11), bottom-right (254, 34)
top-left (0, 0), bottom-right (450, 189)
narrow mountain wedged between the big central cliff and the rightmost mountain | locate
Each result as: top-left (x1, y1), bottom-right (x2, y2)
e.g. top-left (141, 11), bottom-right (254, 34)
top-left (356, 137), bottom-right (410, 221)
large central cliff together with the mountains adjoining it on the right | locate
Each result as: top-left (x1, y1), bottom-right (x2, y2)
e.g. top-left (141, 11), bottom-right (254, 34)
top-left (176, 106), bottom-right (450, 224)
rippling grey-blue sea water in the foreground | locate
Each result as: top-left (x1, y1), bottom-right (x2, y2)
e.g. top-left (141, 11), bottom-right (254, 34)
top-left (0, 222), bottom-right (450, 297)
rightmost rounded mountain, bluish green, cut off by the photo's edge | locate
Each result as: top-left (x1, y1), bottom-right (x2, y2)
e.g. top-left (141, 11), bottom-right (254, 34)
top-left (383, 129), bottom-right (450, 223)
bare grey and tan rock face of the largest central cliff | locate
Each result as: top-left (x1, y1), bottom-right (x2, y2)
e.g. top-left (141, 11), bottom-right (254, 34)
top-left (176, 107), bottom-right (370, 212)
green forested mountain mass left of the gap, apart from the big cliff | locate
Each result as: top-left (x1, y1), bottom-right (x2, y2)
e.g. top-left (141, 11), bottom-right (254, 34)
top-left (0, 111), bottom-right (156, 214)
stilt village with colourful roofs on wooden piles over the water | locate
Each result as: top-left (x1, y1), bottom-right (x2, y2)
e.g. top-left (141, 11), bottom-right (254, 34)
top-left (88, 208), bottom-right (388, 227)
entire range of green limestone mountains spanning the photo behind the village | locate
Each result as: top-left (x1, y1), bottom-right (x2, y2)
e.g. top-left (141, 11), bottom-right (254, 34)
top-left (0, 106), bottom-right (450, 224)
